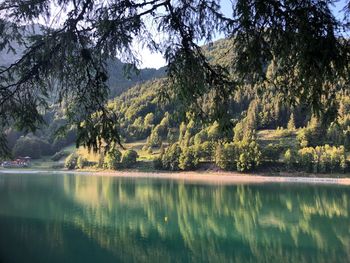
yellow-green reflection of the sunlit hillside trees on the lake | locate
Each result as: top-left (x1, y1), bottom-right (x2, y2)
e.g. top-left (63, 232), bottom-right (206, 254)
top-left (60, 177), bottom-right (350, 262)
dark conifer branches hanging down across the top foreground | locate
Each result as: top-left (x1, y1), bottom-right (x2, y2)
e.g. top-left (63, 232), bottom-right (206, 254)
top-left (0, 0), bottom-right (350, 157)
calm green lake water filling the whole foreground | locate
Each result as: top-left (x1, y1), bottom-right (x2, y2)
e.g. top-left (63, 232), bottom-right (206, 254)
top-left (0, 174), bottom-right (350, 263)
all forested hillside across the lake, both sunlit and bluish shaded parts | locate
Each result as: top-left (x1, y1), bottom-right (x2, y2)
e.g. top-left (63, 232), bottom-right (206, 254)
top-left (2, 37), bottom-right (350, 172)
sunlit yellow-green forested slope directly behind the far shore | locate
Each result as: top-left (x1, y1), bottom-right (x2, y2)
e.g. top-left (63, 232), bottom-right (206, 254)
top-left (109, 75), bottom-right (350, 172)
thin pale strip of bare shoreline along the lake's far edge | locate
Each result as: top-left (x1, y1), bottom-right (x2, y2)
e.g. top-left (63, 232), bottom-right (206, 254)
top-left (0, 169), bottom-right (350, 186)
